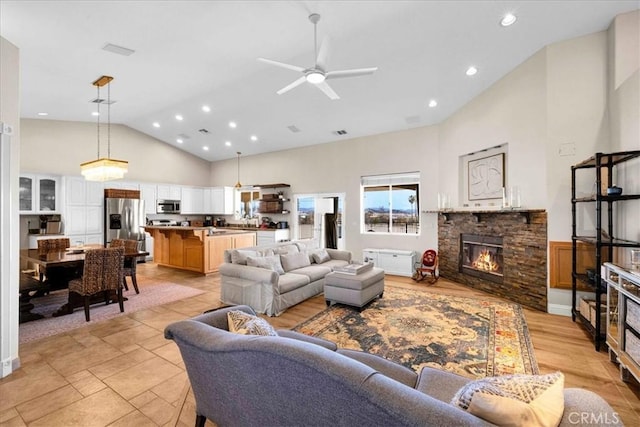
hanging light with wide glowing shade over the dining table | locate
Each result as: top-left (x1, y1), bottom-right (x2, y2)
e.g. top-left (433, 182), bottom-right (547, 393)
top-left (80, 76), bottom-right (129, 181)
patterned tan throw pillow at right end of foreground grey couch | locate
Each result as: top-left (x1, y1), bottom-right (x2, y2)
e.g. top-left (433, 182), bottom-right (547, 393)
top-left (451, 372), bottom-right (564, 427)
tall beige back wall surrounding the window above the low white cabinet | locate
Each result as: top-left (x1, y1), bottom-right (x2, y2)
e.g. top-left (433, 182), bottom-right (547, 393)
top-left (211, 126), bottom-right (439, 259)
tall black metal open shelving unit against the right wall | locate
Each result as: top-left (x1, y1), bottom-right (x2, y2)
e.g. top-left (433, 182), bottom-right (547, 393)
top-left (571, 150), bottom-right (640, 351)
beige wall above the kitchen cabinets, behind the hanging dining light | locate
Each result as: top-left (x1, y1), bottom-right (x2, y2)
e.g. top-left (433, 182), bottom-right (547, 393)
top-left (20, 119), bottom-right (211, 186)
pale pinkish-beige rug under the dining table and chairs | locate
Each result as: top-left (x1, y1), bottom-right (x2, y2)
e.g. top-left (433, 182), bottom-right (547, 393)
top-left (19, 277), bottom-right (204, 344)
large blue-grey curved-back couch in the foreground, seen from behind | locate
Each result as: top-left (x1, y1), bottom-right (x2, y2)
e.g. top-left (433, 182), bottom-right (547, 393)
top-left (165, 306), bottom-right (620, 426)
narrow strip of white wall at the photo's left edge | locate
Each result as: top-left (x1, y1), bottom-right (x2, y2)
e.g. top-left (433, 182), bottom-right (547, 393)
top-left (0, 37), bottom-right (20, 377)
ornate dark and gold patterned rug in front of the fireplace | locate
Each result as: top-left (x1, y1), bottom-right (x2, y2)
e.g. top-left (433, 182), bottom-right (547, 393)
top-left (294, 286), bottom-right (538, 378)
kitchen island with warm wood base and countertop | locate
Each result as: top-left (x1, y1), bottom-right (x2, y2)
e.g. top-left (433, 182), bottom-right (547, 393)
top-left (144, 226), bottom-right (256, 274)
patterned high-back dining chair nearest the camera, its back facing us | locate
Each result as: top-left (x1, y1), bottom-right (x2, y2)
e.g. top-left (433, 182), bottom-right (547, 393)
top-left (69, 247), bottom-right (124, 322)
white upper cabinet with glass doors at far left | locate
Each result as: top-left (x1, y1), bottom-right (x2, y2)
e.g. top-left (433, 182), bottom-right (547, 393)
top-left (19, 174), bottom-right (60, 214)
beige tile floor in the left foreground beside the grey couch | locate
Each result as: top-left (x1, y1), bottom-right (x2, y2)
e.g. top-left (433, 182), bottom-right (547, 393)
top-left (0, 264), bottom-right (220, 427)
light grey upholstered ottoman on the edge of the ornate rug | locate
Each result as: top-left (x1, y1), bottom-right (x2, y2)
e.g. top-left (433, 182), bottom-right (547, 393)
top-left (324, 267), bottom-right (384, 309)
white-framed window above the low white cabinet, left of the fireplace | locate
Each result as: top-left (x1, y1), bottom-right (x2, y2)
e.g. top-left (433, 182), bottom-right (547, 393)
top-left (361, 172), bottom-right (420, 235)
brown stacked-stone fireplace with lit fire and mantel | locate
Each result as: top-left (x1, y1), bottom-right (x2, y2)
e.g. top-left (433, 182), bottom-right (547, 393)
top-left (438, 209), bottom-right (547, 311)
